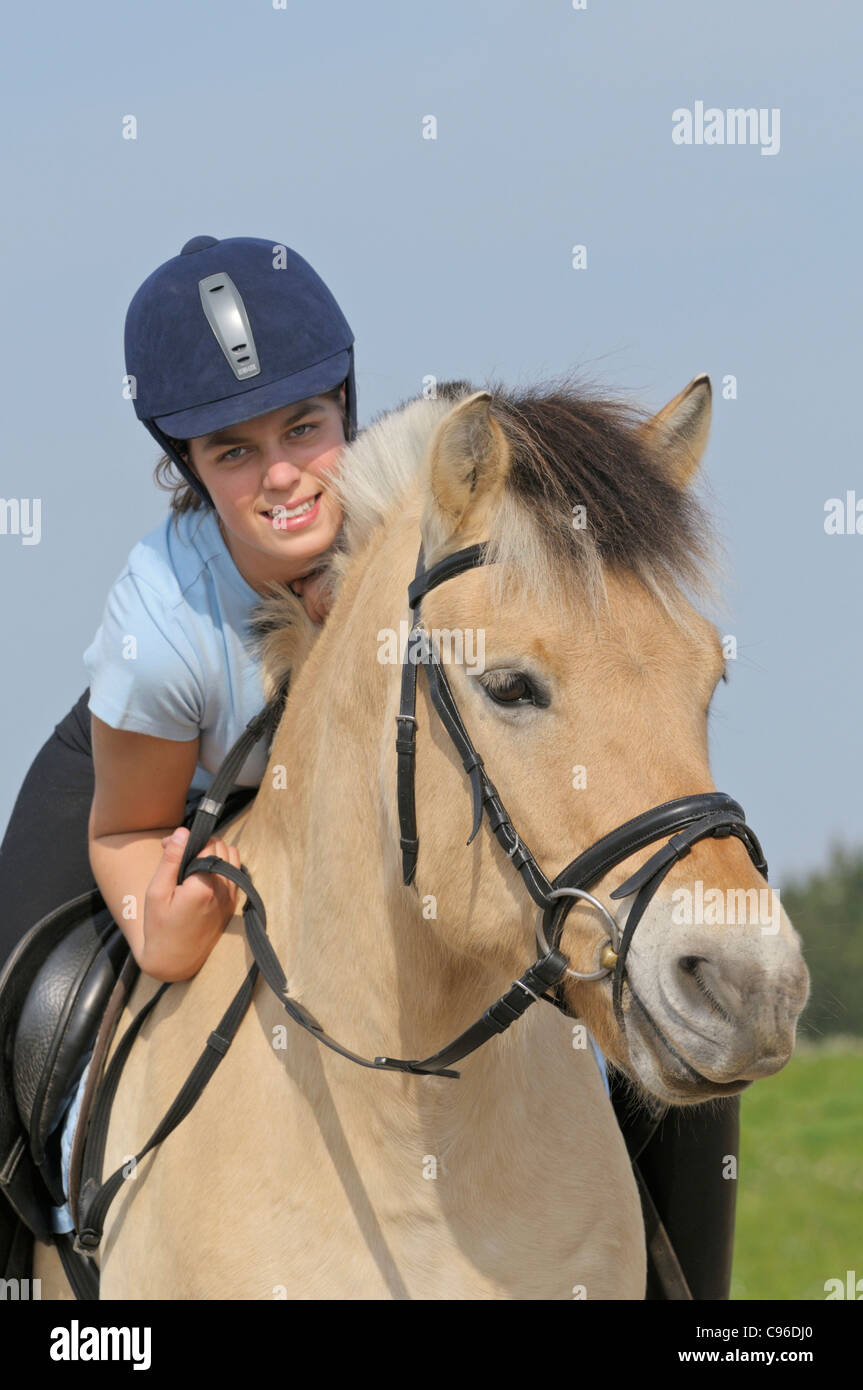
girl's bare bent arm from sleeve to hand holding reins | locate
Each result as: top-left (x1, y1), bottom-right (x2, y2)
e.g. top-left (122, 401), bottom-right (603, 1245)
top-left (89, 714), bottom-right (240, 980)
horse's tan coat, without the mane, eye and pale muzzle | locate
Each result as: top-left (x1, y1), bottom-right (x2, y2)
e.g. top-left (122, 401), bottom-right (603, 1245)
top-left (37, 378), bottom-right (805, 1300)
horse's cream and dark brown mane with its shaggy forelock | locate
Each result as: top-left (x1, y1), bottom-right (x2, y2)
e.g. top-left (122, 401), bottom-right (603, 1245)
top-left (257, 373), bottom-right (714, 695)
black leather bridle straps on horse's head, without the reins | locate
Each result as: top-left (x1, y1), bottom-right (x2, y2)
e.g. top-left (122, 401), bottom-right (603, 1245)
top-left (396, 545), bottom-right (767, 1030)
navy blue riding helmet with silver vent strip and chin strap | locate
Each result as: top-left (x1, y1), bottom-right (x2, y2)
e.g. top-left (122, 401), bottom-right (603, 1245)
top-left (125, 236), bottom-right (357, 503)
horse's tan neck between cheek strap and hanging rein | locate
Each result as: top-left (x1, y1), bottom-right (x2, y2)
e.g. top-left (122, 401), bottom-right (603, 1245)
top-left (240, 516), bottom-right (509, 1078)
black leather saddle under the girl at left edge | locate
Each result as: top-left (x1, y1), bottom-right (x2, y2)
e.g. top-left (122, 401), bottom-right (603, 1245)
top-left (0, 890), bottom-right (129, 1243)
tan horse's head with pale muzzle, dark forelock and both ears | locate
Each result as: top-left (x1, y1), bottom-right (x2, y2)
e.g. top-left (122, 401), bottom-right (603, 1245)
top-left (255, 377), bottom-right (807, 1105)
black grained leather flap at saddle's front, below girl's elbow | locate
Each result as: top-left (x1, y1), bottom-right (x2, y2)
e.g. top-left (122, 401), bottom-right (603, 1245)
top-left (13, 894), bottom-right (129, 1165)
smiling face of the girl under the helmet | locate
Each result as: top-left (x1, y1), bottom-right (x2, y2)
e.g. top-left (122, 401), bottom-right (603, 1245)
top-left (189, 386), bottom-right (345, 589)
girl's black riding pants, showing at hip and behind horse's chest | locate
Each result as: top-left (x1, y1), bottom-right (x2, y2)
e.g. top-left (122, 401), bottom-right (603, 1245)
top-left (0, 691), bottom-right (739, 1298)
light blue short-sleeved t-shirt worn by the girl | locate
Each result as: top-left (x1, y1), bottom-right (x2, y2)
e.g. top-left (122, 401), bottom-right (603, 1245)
top-left (83, 509), bottom-right (267, 792)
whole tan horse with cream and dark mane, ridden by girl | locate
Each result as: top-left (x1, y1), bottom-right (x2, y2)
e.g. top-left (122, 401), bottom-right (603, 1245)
top-left (35, 377), bottom-right (807, 1300)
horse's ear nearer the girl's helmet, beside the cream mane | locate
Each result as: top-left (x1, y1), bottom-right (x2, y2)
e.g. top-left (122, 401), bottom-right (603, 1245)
top-left (421, 391), bottom-right (510, 555)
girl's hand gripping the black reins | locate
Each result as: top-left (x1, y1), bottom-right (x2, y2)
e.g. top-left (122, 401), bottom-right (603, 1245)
top-left (138, 826), bottom-right (240, 980)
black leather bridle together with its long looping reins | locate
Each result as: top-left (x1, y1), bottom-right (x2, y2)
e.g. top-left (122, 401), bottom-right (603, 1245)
top-left (75, 545), bottom-right (767, 1255)
